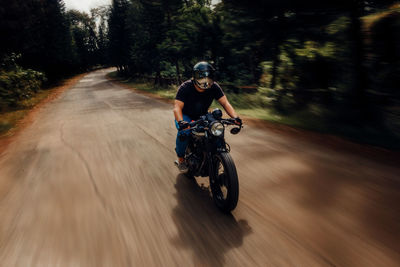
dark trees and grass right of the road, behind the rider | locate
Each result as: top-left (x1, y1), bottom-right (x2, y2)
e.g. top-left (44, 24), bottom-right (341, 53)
top-left (108, 0), bottom-right (400, 148)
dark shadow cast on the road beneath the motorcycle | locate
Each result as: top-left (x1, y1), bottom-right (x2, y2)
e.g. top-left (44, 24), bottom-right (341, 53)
top-left (171, 175), bottom-right (251, 266)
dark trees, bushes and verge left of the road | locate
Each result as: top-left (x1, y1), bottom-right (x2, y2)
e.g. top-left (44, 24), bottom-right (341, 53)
top-left (0, 0), bottom-right (108, 135)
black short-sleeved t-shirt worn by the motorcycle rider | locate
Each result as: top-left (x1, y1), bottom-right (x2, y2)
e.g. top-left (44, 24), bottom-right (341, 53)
top-left (175, 80), bottom-right (224, 120)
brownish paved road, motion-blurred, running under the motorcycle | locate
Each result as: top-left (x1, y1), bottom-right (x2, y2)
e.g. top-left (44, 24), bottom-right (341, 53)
top-left (0, 70), bottom-right (400, 267)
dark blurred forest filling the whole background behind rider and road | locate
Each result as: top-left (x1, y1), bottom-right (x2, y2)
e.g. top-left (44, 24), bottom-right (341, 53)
top-left (0, 0), bottom-right (400, 149)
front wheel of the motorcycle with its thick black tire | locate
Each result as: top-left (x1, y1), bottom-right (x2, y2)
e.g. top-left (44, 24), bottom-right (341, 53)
top-left (210, 153), bottom-right (239, 213)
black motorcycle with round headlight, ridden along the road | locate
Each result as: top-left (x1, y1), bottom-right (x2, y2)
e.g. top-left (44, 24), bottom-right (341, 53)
top-left (183, 109), bottom-right (243, 213)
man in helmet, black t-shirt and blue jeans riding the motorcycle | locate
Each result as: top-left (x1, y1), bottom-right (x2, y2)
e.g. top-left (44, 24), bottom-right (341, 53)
top-left (174, 61), bottom-right (242, 172)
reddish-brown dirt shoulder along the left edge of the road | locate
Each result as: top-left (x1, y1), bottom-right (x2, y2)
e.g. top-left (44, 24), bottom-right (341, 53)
top-left (0, 73), bottom-right (86, 155)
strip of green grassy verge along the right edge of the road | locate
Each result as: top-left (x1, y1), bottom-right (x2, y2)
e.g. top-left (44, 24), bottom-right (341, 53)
top-left (108, 72), bottom-right (400, 149)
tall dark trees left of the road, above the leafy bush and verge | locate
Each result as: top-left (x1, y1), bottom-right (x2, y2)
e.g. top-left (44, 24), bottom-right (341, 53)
top-left (0, 0), bottom-right (108, 82)
